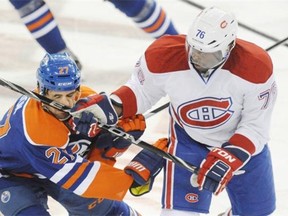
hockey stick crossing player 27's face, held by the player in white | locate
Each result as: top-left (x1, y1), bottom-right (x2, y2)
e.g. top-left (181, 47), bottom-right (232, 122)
top-left (0, 78), bottom-right (198, 173)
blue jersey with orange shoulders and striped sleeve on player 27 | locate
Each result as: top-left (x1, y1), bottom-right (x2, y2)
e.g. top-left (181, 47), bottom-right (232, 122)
top-left (0, 87), bottom-right (133, 200)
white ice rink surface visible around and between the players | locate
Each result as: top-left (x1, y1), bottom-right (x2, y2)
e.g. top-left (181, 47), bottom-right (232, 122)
top-left (0, 0), bottom-right (288, 216)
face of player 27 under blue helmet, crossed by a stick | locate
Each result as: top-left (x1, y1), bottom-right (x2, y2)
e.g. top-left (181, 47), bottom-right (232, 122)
top-left (45, 90), bottom-right (80, 120)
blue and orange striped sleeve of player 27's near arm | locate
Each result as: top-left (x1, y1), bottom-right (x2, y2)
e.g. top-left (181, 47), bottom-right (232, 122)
top-left (22, 142), bottom-right (133, 201)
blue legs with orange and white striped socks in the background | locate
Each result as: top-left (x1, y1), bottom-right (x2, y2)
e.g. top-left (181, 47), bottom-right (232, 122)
top-left (10, 0), bottom-right (178, 69)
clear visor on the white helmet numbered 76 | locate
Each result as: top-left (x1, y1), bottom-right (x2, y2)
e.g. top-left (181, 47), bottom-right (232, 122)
top-left (188, 45), bottom-right (227, 69)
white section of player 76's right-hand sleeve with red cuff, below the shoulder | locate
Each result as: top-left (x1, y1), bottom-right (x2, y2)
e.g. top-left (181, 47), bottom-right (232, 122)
top-left (229, 75), bottom-right (277, 154)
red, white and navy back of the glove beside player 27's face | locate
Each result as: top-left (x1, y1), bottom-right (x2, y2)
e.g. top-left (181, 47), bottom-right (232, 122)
top-left (70, 93), bottom-right (118, 127)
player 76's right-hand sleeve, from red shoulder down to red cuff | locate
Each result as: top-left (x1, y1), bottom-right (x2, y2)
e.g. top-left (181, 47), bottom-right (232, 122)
top-left (224, 39), bottom-right (277, 154)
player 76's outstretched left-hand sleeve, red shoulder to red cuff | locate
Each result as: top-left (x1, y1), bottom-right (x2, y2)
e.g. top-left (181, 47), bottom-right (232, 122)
top-left (112, 35), bottom-right (189, 117)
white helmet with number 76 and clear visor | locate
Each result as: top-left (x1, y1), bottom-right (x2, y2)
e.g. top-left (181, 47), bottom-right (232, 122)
top-left (186, 7), bottom-right (238, 69)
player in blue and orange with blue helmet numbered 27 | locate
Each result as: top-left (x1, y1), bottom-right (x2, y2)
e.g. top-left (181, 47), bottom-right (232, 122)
top-left (0, 53), bottom-right (167, 216)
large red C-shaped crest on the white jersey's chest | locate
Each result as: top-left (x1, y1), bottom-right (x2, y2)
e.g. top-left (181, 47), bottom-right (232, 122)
top-left (178, 97), bottom-right (233, 129)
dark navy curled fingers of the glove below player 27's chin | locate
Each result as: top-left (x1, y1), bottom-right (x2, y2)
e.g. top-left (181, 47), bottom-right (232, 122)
top-left (68, 112), bottom-right (100, 137)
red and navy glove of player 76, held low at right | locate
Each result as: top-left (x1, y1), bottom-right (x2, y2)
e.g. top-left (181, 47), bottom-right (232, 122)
top-left (191, 143), bottom-right (251, 195)
